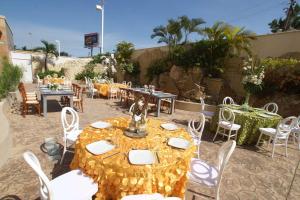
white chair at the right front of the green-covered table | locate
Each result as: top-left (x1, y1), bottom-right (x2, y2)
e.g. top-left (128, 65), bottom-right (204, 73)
top-left (256, 116), bottom-right (297, 158)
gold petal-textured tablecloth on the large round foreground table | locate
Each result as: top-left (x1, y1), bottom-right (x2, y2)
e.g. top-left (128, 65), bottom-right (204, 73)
top-left (70, 117), bottom-right (195, 200)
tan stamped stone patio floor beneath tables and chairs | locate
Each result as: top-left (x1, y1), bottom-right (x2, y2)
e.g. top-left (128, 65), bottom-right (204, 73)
top-left (0, 85), bottom-right (300, 200)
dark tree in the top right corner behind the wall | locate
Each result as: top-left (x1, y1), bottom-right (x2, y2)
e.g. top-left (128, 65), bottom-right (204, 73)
top-left (268, 0), bottom-right (300, 33)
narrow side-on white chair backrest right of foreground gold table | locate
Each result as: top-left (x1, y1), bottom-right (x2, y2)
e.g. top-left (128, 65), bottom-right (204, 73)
top-left (217, 140), bottom-right (236, 190)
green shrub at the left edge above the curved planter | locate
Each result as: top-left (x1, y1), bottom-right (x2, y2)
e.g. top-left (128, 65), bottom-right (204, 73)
top-left (0, 59), bottom-right (23, 99)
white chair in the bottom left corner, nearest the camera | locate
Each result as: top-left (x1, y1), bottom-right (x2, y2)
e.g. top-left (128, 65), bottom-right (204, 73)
top-left (23, 151), bottom-right (98, 200)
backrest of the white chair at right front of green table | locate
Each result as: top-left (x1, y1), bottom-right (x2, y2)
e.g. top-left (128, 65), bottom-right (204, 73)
top-left (275, 116), bottom-right (297, 138)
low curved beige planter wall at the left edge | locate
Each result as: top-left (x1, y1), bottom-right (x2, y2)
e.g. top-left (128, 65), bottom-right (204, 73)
top-left (0, 100), bottom-right (12, 168)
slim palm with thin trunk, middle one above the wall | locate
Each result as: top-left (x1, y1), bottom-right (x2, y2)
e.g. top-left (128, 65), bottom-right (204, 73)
top-left (178, 15), bottom-right (205, 44)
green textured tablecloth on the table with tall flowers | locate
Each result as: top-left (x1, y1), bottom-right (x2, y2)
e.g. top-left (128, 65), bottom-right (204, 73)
top-left (211, 105), bottom-right (282, 145)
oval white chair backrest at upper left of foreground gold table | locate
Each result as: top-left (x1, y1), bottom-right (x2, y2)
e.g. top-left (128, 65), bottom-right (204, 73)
top-left (61, 107), bottom-right (79, 139)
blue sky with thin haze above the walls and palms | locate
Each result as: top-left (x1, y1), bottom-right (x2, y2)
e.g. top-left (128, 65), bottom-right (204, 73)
top-left (0, 0), bottom-right (289, 56)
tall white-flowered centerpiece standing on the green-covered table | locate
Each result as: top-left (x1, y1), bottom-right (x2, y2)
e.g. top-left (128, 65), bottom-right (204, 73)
top-left (242, 58), bottom-right (265, 110)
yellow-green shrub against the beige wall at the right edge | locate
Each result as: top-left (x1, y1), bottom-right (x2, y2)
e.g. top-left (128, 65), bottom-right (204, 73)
top-left (262, 58), bottom-right (300, 94)
